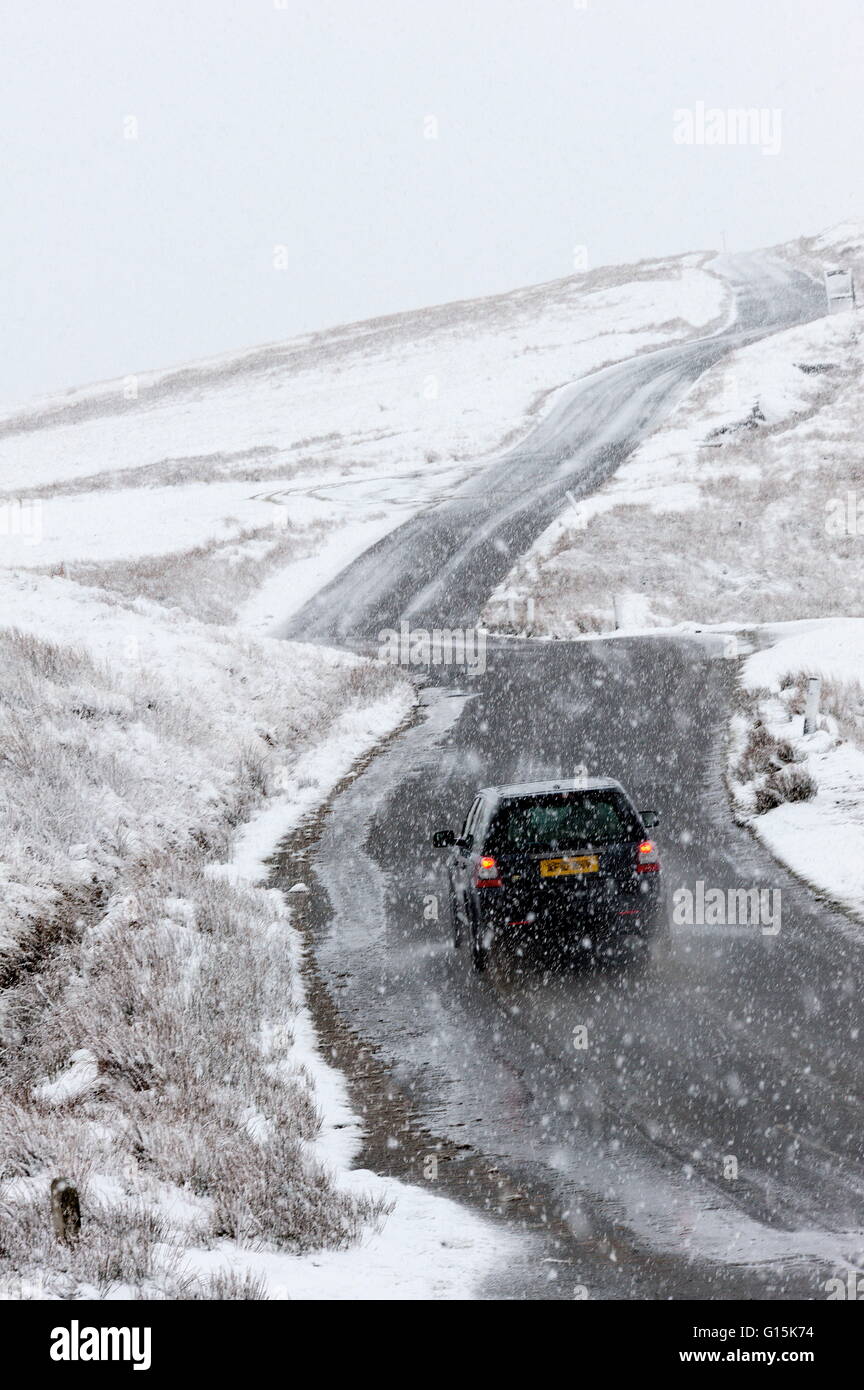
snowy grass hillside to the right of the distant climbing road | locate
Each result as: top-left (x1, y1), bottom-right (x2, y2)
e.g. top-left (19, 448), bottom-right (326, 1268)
top-left (485, 228), bottom-right (864, 637)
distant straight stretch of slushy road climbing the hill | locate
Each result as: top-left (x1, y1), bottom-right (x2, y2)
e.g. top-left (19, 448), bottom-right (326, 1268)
top-left (278, 253), bottom-right (824, 646)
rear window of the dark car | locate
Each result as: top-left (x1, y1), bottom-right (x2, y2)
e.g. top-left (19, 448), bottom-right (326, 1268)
top-left (486, 791), bottom-right (640, 853)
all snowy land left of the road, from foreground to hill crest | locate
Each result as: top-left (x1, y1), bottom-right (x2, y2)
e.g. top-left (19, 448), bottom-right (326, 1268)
top-left (0, 256), bottom-right (728, 1298)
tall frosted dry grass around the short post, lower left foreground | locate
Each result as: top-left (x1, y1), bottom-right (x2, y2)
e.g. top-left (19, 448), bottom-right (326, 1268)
top-left (0, 858), bottom-right (381, 1295)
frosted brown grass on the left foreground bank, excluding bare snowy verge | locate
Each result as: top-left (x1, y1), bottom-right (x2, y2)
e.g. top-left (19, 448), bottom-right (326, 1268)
top-left (0, 631), bottom-right (405, 1298)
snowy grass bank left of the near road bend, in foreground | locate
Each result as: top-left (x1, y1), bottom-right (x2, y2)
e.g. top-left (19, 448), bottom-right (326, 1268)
top-left (0, 573), bottom-right (508, 1298)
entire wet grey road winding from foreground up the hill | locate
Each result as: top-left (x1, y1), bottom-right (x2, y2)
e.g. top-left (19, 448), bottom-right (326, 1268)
top-left (277, 255), bottom-right (864, 1298)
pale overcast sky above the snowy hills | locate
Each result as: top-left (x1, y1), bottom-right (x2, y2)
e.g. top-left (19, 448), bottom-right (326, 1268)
top-left (0, 0), bottom-right (864, 404)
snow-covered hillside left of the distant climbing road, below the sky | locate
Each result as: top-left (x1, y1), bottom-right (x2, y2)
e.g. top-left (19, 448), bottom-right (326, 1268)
top-left (0, 256), bottom-right (728, 628)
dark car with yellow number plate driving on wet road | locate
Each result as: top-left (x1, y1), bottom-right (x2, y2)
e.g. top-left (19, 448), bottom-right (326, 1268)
top-left (432, 777), bottom-right (663, 970)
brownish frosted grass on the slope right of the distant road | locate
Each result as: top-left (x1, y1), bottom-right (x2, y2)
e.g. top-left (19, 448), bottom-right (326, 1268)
top-left (486, 333), bottom-right (864, 637)
